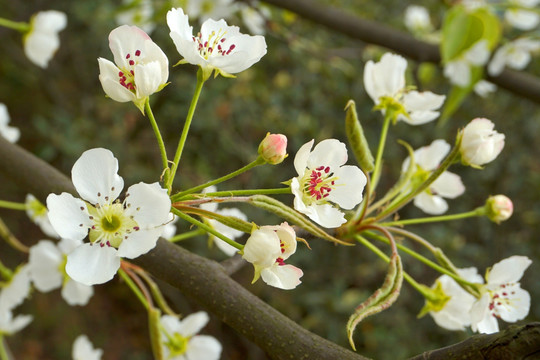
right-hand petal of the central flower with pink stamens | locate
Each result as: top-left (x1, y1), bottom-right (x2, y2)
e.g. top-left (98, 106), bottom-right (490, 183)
top-left (327, 165), bottom-right (367, 210)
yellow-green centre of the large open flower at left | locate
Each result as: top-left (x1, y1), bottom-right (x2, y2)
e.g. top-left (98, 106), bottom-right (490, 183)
top-left (88, 202), bottom-right (139, 248)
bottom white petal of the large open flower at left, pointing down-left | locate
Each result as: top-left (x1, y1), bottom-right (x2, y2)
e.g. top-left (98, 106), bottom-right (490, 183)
top-left (66, 244), bottom-right (120, 286)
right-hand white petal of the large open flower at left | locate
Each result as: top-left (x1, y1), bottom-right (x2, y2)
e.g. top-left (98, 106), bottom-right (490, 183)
top-left (124, 182), bottom-right (171, 228)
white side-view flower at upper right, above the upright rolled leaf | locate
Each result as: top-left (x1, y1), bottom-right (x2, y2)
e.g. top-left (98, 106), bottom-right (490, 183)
top-left (364, 53), bottom-right (445, 125)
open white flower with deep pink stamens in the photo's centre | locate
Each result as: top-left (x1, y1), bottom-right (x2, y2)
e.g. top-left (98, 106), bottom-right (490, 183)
top-left (291, 139), bottom-right (367, 228)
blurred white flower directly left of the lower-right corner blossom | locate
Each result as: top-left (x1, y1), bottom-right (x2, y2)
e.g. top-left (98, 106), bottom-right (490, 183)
top-left (429, 267), bottom-right (483, 330)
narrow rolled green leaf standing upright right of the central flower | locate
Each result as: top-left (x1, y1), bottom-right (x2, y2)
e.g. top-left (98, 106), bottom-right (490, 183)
top-left (345, 100), bottom-right (375, 173)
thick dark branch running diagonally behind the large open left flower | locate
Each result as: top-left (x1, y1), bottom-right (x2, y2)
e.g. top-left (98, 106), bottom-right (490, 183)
top-left (0, 136), bottom-right (366, 360)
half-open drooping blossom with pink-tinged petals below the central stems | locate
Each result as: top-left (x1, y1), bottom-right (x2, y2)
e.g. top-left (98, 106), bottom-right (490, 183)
top-left (242, 222), bottom-right (304, 290)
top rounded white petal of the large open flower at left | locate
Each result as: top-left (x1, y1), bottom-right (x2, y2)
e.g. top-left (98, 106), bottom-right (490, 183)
top-left (70, 148), bottom-right (124, 205)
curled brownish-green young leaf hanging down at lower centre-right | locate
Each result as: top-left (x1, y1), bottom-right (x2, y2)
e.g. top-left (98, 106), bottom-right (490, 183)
top-left (347, 253), bottom-right (403, 351)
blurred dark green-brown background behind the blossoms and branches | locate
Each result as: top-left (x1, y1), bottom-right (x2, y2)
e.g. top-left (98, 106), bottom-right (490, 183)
top-left (0, 0), bottom-right (540, 359)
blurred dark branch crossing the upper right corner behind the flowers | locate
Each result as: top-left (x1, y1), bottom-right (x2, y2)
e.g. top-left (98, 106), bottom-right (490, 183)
top-left (263, 0), bottom-right (540, 103)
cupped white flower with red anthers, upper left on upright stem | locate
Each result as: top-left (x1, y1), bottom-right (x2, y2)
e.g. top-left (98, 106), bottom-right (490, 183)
top-left (98, 25), bottom-right (169, 113)
